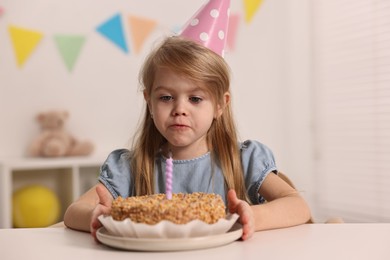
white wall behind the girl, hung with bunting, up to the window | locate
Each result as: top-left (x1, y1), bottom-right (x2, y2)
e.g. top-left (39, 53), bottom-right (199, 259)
top-left (0, 0), bottom-right (311, 208)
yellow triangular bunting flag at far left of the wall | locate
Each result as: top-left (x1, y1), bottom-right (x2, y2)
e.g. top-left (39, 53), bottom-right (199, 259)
top-left (8, 25), bottom-right (43, 67)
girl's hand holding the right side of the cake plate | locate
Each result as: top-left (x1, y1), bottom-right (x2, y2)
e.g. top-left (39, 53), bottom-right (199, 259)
top-left (227, 189), bottom-right (255, 240)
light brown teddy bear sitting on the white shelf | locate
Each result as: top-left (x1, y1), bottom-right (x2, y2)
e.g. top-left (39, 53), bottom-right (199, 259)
top-left (28, 110), bottom-right (94, 157)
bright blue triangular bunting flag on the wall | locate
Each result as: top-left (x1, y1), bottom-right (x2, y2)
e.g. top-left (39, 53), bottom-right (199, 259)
top-left (96, 14), bottom-right (128, 53)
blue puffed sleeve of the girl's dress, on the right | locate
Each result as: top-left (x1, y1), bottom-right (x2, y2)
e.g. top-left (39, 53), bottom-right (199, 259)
top-left (241, 140), bottom-right (277, 204)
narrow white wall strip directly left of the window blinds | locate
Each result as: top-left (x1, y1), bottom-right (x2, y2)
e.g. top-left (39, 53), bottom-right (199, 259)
top-left (283, 0), bottom-right (314, 213)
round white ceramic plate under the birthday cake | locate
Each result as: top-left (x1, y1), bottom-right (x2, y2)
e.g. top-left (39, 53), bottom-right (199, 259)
top-left (96, 223), bottom-right (242, 251)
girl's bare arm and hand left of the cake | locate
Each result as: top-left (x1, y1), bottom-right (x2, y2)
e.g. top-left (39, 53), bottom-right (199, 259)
top-left (64, 183), bottom-right (113, 236)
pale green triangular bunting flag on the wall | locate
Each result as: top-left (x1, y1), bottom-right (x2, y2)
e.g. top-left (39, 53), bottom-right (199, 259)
top-left (54, 35), bottom-right (85, 71)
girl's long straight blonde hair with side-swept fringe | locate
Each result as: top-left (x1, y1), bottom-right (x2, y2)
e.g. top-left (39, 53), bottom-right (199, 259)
top-left (131, 37), bottom-right (249, 201)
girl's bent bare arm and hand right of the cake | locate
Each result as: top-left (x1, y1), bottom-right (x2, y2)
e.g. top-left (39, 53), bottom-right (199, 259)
top-left (228, 173), bottom-right (311, 240)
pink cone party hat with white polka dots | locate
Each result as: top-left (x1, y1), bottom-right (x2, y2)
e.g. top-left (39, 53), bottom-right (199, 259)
top-left (180, 0), bottom-right (230, 57)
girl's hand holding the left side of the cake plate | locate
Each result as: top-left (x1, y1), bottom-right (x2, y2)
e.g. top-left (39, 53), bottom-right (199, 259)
top-left (90, 185), bottom-right (113, 241)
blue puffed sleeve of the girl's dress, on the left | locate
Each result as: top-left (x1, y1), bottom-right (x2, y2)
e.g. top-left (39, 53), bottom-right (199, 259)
top-left (99, 149), bottom-right (132, 198)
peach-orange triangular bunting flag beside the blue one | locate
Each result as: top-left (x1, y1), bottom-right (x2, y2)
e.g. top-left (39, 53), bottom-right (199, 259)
top-left (129, 16), bottom-right (157, 53)
